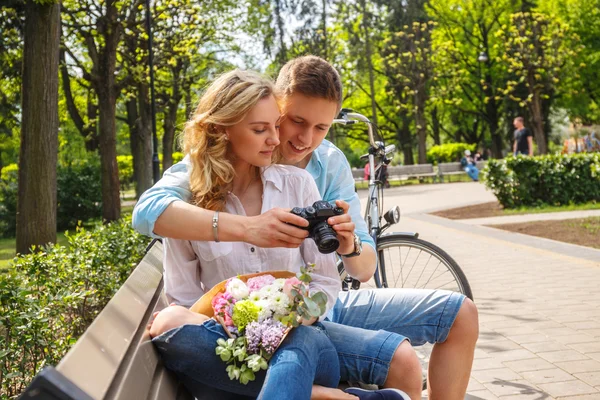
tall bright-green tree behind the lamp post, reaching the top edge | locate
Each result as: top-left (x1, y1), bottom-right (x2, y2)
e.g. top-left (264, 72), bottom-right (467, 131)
top-left (429, 0), bottom-right (514, 157)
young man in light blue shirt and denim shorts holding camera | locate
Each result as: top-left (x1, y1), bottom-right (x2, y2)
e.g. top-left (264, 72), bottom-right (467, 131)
top-left (133, 56), bottom-right (478, 400)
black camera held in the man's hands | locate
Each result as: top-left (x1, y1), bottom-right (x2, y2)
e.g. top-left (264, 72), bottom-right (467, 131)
top-left (291, 200), bottom-right (344, 254)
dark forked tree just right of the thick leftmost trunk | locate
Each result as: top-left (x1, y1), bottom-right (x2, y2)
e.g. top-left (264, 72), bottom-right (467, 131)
top-left (63, 0), bottom-right (142, 222)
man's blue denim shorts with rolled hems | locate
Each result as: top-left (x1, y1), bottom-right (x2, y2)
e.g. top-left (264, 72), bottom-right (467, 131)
top-left (322, 289), bottom-right (466, 386)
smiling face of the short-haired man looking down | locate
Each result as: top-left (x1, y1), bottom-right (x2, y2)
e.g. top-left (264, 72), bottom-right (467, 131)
top-left (279, 93), bottom-right (338, 167)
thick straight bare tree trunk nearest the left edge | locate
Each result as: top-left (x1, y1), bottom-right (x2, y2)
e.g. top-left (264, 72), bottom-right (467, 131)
top-left (17, 0), bottom-right (60, 254)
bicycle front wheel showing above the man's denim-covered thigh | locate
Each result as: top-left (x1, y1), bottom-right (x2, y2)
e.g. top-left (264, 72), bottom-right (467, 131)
top-left (361, 234), bottom-right (473, 300)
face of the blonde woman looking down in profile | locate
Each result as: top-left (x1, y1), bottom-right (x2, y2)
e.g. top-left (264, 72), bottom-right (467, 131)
top-left (225, 96), bottom-right (281, 167)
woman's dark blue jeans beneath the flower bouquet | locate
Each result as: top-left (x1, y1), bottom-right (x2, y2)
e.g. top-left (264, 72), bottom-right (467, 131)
top-left (152, 319), bottom-right (340, 400)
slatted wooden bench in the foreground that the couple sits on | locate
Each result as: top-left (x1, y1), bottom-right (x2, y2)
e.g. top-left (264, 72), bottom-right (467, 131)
top-left (21, 241), bottom-right (193, 400)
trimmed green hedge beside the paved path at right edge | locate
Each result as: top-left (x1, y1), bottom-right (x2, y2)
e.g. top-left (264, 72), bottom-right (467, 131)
top-left (482, 153), bottom-right (600, 208)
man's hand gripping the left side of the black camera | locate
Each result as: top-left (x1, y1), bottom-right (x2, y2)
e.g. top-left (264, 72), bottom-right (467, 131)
top-left (244, 208), bottom-right (308, 248)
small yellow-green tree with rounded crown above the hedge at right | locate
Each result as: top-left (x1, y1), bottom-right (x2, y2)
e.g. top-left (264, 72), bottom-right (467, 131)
top-left (497, 12), bottom-right (577, 154)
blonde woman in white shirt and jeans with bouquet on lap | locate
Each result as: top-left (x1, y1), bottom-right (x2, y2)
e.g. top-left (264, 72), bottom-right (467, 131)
top-left (150, 71), bottom-right (407, 400)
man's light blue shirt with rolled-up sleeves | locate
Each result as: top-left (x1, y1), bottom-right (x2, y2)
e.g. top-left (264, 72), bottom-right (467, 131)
top-left (133, 140), bottom-right (375, 248)
